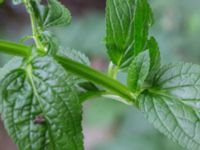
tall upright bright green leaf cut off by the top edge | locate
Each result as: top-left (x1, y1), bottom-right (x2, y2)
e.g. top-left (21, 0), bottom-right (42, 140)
top-left (106, 0), bottom-right (153, 68)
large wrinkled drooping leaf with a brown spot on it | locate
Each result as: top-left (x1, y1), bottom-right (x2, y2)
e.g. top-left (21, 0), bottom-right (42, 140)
top-left (0, 56), bottom-right (83, 150)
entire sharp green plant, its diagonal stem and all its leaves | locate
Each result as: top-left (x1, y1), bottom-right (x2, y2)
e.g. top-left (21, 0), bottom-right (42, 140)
top-left (0, 0), bottom-right (200, 150)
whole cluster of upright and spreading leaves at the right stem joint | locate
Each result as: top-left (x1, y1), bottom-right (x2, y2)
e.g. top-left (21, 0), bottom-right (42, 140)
top-left (106, 0), bottom-right (200, 150)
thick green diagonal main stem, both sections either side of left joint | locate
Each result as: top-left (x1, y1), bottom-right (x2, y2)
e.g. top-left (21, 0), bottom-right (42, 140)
top-left (0, 41), bottom-right (136, 103)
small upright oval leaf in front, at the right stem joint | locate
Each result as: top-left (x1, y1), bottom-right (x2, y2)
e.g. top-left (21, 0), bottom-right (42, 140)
top-left (127, 50), bottom-right (150, 91)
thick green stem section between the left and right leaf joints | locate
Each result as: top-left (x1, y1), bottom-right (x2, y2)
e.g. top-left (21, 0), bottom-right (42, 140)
top-left (55, 55), bottom-right (136, 102)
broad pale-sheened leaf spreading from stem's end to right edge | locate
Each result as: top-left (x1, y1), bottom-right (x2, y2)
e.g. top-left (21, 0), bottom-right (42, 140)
top-left (139, 63), bottom-right (200, 150)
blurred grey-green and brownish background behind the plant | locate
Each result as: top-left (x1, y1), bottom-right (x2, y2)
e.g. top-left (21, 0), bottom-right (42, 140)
top-left (0, 0), bottom-right (200, 150)
